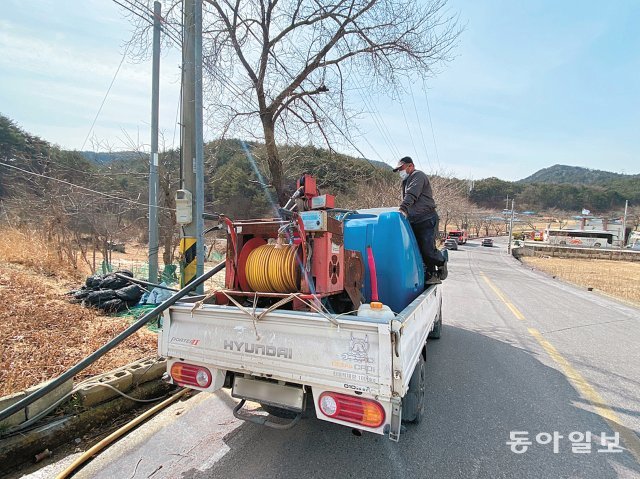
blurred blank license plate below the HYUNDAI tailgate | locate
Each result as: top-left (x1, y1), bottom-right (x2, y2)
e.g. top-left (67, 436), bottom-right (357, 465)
top-left (231, 376), bottom-right (304, 411)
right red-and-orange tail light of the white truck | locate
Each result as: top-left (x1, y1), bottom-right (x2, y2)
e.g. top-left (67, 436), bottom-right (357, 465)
top-left (318, 392), bottom-right (385, 428)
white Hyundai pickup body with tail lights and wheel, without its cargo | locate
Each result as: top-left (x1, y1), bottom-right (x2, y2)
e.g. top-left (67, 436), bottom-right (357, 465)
top-left (159, 285), bottom-right (442, 441)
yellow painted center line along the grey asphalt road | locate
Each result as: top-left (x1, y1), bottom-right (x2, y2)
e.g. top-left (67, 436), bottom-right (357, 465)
top-left (480, 272), bottom-right (640, 463)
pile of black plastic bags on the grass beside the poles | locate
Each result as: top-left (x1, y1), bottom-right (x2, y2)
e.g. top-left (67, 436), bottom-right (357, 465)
top-left (69, 270), bottom-right (146, 313)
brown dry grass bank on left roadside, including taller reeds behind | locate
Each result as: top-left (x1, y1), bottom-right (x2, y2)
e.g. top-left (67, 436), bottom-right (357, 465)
top-left (0, 228), bottom-right (157, 396)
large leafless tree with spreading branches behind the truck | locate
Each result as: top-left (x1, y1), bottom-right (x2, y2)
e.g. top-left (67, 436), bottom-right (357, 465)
top-left (124, 0), bottom-right (460, 203)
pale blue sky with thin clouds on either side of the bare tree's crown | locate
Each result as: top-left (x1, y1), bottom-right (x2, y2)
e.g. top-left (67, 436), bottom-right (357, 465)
top-left (0, 0), bottom-right (640, 179)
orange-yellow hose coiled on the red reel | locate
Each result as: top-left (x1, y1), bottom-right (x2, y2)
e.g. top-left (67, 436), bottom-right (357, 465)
top-left (246, 244), bottom-right (300, 293)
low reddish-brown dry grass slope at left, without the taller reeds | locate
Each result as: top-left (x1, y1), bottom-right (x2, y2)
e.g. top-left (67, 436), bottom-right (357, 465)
top-left (0, 263), bottom-right (157, 396)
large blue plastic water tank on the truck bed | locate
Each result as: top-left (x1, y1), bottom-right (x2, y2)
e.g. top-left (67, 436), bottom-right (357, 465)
top-left (344, 208), bottom-right (424, 313)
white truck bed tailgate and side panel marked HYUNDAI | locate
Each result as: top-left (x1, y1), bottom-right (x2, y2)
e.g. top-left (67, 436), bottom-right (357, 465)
top-left (159, 286), bottom-right (441, 440)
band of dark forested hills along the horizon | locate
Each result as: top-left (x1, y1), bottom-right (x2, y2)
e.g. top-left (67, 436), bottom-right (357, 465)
top-left (0, 115), bottom-right (640, 218)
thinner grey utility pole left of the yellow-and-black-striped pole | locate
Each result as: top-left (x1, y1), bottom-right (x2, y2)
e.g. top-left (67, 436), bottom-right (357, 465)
top-left (149, 2), bottom-right (162, 283)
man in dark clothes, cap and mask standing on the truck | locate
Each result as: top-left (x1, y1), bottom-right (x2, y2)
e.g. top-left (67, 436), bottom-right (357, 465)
top-left (393, 156), bottom-right (449, 284)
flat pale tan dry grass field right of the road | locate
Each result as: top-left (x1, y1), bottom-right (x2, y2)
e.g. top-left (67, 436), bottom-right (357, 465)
top-left (522, 257), bottom-right (640, 304)
